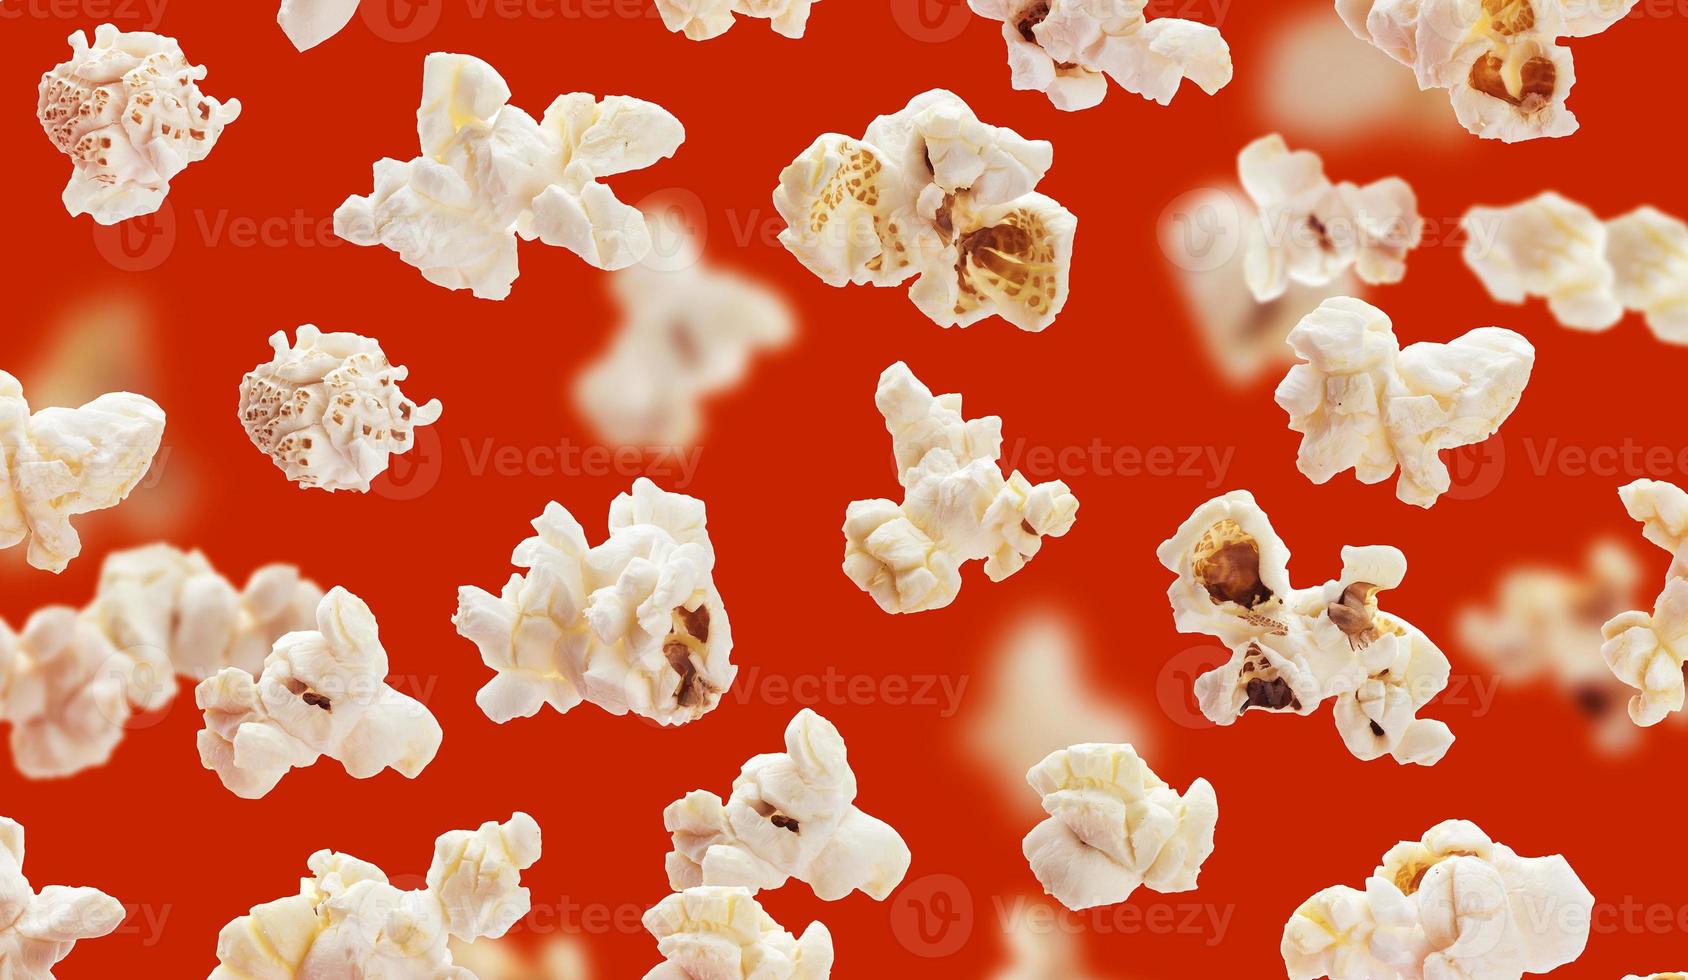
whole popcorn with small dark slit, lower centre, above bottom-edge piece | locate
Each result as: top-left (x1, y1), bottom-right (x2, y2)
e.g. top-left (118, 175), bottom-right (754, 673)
top-left (662, 708), bottom-right (912, 902)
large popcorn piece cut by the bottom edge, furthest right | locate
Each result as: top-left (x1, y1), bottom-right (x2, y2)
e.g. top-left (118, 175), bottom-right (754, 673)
top-left (1281, 820), bottom-right (1593, 980)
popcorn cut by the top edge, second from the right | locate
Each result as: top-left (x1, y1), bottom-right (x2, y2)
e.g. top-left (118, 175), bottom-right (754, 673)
top-left (967, 0), bottom-right (1231, 111)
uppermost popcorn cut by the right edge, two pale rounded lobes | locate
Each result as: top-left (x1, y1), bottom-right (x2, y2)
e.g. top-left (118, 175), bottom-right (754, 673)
top-left (1460, 191), bottom-right (1688, 344)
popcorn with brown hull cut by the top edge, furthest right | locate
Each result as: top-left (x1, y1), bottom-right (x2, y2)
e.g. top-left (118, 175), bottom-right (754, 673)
top-left (1337, 0), bottom-right (1639, 143)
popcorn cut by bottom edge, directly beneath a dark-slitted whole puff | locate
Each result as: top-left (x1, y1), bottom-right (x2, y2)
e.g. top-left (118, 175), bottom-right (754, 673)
top-left (645, 887), bottom-right (832, 980)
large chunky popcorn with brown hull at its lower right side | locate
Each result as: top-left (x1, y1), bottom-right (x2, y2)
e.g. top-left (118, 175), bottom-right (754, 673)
top-left (452, 477), bottom-right (738, 725)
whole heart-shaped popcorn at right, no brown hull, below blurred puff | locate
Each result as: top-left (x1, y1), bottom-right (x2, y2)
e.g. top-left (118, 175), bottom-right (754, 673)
top-left (1276, 297), bottom-right (1536, 508)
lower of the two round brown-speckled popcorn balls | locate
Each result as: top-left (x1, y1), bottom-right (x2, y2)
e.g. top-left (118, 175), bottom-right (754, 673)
top-left (240, 324), bottom-right (441, 493)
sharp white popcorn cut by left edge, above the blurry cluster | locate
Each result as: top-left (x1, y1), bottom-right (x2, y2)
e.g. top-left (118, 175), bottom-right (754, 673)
top-left (0, 371), bottom-right (164, 573)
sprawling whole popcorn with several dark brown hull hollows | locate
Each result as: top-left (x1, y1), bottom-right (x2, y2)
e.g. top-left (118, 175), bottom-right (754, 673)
top-left (1156, 491), bottom-right (1453, 766)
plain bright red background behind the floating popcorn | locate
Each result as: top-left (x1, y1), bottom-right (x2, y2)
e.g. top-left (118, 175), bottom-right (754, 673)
top-left (0, 0), bottom-right (1688, 980)
